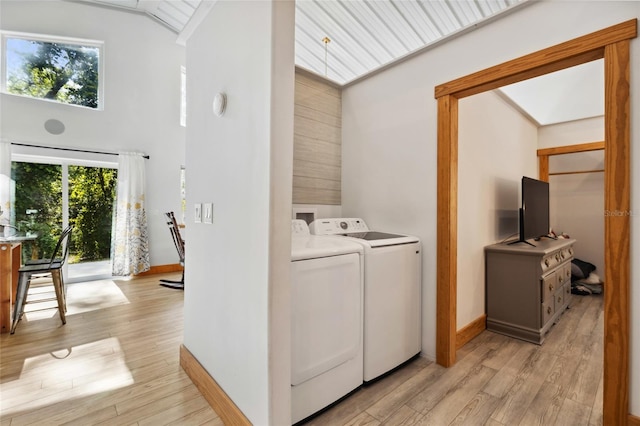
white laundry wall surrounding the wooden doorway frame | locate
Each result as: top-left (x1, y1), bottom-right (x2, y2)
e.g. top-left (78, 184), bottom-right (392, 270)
top-left (342, 1), bottom-right (640, 414)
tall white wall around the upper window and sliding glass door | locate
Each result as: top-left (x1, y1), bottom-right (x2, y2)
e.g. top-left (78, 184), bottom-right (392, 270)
top-left (0, 0), bottom-right (184, 265)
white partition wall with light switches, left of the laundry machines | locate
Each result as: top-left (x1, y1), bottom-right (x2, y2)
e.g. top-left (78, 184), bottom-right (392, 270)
top-left (184, 1), bottom-right (294, 425)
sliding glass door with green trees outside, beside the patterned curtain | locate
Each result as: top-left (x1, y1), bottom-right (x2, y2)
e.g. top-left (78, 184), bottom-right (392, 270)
top-left (12, 159), bottom-right (117, 282)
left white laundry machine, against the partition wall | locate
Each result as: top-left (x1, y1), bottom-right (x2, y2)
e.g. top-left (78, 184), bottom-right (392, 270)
top-left (291, 220), bottom-right (363, 423)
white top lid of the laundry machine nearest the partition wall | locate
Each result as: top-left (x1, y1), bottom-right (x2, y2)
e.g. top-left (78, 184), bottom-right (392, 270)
top-left (291, 235), bottom-right (363, 261)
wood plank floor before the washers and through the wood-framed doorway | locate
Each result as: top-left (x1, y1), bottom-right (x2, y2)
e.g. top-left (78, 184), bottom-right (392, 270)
top-left (305, 296), bottom-right (604, 426)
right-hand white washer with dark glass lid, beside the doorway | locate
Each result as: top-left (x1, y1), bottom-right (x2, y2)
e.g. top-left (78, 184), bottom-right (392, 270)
top-left (310, 218), bottom-right (422, 382)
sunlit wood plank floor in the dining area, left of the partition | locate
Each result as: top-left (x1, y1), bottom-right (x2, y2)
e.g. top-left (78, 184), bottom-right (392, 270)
top-left (0, 274), bottom-right (223, 426)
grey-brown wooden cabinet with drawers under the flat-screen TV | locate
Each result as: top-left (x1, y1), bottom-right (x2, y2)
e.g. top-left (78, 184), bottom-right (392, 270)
top-left (485, 239), bottom-right (575, 345)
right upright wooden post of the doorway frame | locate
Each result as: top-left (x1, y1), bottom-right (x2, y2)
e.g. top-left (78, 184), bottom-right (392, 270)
top-left (603, 40), bottom-right (631, 425)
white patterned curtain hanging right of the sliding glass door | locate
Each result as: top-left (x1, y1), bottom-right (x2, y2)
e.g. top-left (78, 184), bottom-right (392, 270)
top-left (111, 152), bottom-right (151, 276)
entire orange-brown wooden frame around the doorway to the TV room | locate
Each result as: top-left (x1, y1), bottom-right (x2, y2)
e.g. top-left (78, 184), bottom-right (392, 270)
top-left (435, 19), bottom-right (637, 425)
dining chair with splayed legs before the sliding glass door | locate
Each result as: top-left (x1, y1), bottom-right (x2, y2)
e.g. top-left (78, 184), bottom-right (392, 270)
top-left (11, 226), bottom-right (73, 334)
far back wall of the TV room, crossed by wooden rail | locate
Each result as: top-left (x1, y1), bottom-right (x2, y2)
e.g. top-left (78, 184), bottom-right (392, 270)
top-left (538, 117), bottom-right (604, 272)
